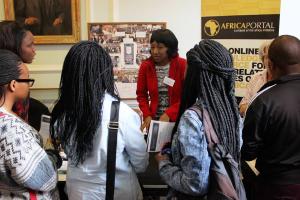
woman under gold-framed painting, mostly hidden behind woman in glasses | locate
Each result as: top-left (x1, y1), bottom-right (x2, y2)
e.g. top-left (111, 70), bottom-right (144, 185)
top-left (0, 21), bottom-right (35, 121)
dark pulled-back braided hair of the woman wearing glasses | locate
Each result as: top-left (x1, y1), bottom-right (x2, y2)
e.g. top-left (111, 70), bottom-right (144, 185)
top-left (0, 49), bottom-right (22, 106)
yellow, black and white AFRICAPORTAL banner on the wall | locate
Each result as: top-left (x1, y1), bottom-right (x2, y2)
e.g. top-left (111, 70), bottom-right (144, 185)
top-left (201, 0), bottom-right (280, 96)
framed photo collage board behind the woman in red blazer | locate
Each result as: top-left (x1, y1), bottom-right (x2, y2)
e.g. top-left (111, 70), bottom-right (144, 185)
top-left (87, 22), bottom-right (166, 100)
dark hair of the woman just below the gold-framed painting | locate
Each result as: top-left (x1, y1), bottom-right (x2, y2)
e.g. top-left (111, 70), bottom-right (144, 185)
top-left (0, 21), bottom-right (28, 56)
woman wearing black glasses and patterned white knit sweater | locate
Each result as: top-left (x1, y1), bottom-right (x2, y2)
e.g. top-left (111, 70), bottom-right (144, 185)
top-left (0, 49), bottom-right (61, 200)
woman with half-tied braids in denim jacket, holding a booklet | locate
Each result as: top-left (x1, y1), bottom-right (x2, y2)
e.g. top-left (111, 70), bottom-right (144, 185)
top-left (156, 40), bottom-right (240, 199)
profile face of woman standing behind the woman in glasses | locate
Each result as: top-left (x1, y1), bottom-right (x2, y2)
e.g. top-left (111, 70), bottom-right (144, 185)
top-left (20, 31), bottom-right (35, 64)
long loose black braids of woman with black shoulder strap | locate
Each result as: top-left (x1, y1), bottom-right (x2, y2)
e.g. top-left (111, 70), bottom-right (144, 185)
top-left (50, 41), bottom-right (119, 165)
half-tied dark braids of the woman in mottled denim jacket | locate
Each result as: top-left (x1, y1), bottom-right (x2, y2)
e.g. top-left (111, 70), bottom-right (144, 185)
top-left (175, 40), bottom-right (240, 161)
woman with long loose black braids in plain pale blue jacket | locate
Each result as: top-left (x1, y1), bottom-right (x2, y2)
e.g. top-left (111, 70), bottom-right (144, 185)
top-left (51, 41), bottom-right (148, 200)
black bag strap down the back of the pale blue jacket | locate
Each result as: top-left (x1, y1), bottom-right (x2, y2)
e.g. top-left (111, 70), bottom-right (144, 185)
top-left (105, 101), bottom-right (120, 200)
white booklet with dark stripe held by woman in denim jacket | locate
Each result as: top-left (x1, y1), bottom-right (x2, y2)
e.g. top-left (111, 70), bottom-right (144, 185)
top-left (147, 120), bottom-right (175, 152)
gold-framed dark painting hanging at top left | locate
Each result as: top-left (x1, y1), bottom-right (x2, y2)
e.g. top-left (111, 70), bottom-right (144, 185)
top-left (3, 0), bottom-right (80, 44)
